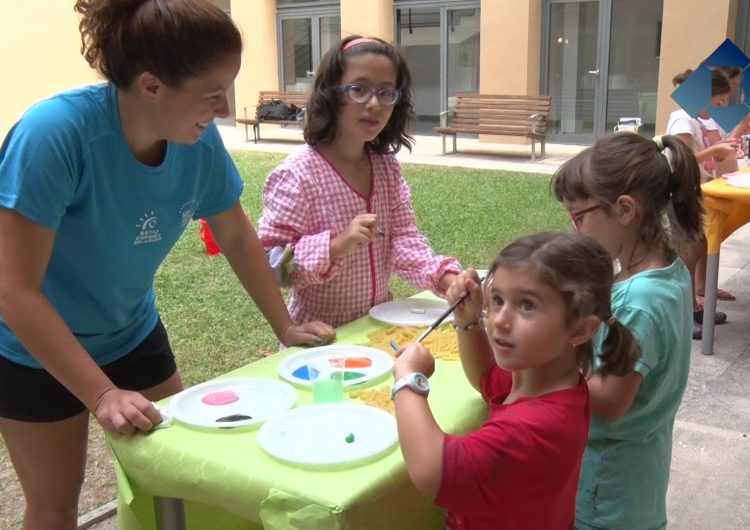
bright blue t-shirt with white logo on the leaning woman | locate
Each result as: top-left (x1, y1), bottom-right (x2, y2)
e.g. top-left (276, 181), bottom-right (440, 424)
top-left (0, 83), bottom-right (242, 367)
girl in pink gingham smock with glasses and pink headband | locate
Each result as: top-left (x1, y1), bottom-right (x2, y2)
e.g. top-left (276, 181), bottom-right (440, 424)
top-left (258, 37), bottom-right (461, 327)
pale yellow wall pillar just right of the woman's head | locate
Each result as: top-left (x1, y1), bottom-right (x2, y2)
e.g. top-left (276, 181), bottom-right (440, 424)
top-left (232, 0), bottom-right (279, 117)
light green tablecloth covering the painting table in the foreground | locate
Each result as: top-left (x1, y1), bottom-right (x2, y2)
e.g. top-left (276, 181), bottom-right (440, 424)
top-left (108, 310), bottom-right (487, 530)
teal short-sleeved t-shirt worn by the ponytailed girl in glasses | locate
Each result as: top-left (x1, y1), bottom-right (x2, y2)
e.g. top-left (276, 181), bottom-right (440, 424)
top-left (576, 259), bottom-right (692, 530)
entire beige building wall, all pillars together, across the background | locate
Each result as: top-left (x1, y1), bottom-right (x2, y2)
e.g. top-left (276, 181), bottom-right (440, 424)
top-left (0, 0), bottom-right (748, 141)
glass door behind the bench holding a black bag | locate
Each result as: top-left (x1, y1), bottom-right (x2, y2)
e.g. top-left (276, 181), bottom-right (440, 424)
top-left (279, 15), bottom-right (341, 91)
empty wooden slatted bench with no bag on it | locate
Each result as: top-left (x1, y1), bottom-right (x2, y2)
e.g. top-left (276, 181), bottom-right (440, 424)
top-left (434, 94), bottom-right (551, 162)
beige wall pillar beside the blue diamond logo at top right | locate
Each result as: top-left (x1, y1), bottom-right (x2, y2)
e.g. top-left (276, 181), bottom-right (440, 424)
top-left (656, 0), bottom-right (737, 134)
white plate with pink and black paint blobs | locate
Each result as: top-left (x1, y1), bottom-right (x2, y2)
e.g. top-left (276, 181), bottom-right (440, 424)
top-left (168, 377), bottom-right (297, 429)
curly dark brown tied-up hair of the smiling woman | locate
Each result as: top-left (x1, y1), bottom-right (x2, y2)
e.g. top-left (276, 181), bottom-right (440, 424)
top-left (74, 0), bottom-right (242, 88)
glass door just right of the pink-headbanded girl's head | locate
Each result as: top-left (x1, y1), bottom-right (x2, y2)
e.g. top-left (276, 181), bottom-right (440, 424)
top-left (396, 2), bottom-right (480, 134)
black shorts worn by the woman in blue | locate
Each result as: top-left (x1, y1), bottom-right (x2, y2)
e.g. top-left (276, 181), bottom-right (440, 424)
top-left (0, 320), bottom-right (177, 423)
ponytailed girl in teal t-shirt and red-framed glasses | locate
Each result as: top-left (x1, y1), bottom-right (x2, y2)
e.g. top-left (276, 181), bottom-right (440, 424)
top-left (551, 133), bottom-right (703, 529)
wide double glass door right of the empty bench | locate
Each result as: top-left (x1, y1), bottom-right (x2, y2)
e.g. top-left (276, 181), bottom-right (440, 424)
top-left (542, 0), bottom-right (664, 144)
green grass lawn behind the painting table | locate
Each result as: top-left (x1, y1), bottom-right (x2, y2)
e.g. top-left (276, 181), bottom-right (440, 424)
top-left (0, 148), bottom-right (569, 529)
